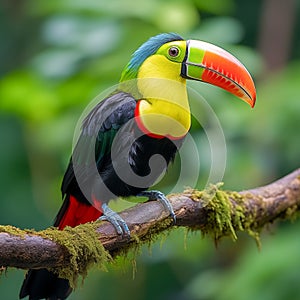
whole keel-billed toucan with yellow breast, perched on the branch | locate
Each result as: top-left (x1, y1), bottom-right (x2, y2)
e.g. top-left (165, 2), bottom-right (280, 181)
top-left (20, 33), bottom-right (256, 300)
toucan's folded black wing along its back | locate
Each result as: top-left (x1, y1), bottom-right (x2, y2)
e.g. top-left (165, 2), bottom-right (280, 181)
top-left (61, 92), bottom-right (136, 202)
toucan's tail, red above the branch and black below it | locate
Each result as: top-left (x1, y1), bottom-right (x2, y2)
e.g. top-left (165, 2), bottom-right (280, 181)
top-left (19, 195), bottom-right (102, 300)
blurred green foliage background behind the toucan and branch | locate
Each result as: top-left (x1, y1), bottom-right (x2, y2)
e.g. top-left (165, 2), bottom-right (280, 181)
top-left (0, 0), bottom-right (300, 300)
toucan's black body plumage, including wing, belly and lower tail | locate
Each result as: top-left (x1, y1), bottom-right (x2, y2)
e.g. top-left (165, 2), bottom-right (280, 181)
top-left (20, 92), bottom-right (183, 300)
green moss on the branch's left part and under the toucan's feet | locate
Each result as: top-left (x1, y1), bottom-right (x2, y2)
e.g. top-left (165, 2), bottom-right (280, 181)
top-left (0, 212), bottom-right (176, 288)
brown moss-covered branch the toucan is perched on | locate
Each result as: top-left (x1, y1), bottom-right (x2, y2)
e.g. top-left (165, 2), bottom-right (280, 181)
top-left (0, 169), bottom-right (300, 279)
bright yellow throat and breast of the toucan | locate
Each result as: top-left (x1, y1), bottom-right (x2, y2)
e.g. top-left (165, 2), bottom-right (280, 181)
top-left (138, 55), bottom-right (191, 139)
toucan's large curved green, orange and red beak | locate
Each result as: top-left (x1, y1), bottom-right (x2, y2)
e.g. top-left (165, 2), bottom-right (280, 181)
top-left (181, 40), bottom-right (256, 107)
